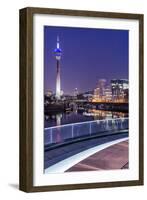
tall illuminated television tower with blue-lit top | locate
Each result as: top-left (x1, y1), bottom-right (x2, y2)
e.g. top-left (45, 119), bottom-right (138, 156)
top-left (54, 36), bottom-right (62, 100)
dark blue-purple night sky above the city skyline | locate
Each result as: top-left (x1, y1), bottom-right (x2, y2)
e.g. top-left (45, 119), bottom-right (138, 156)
top-left (44, 26), bottom-right (129, 94)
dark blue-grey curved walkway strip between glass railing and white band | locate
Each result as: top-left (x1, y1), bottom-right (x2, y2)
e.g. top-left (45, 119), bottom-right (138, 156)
top-left (44, 132), bottom-right (128, 169)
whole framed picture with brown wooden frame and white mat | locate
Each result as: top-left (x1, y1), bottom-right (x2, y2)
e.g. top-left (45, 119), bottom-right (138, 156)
top-left (19, 8), bottom-right (143, 192)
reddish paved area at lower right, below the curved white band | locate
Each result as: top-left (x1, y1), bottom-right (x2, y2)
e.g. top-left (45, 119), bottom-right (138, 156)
top-left (67, 140), bottom-right (129, 172)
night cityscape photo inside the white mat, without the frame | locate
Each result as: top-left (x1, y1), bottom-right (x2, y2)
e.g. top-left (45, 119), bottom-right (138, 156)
top-left (44, 26), bottom-right (129, 173)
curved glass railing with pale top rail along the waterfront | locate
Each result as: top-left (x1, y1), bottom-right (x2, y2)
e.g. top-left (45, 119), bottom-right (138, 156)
top-left (44, 118), bottom-right (129, 146)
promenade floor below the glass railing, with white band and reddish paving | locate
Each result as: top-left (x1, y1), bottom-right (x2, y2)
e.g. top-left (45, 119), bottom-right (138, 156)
top-left (44, 132), bottom-right (128, 173)
